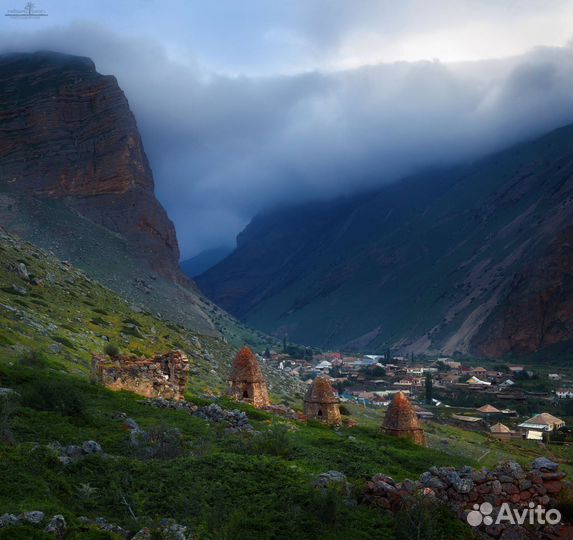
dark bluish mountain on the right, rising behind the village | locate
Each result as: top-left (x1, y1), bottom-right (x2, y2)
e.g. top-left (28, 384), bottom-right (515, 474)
top-left (196, 126), bottom-right (573, 357)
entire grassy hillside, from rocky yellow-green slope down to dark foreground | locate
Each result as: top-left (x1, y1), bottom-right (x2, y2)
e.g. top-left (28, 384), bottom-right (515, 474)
top-left (0, 229), bottom-right (564, 540)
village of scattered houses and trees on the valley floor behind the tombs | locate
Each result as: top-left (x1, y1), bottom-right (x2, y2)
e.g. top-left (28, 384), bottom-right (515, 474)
top-left (258, 347), bottom-right (573, 444)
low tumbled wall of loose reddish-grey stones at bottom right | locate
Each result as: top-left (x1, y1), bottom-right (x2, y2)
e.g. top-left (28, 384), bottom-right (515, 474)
top-left (363, 458), bottom-right (565, 538)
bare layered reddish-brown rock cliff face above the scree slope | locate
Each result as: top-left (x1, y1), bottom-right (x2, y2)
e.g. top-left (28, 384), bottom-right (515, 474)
top-left (0, 52), bottom-right (180, 279)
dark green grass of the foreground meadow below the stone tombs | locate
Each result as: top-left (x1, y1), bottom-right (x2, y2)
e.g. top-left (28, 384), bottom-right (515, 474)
top-left (0, 362), bottom-right (474, 539)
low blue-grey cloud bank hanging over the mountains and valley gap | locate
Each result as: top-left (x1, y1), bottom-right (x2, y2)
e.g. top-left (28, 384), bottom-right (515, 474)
top-left (0, 23), bottom-right (573, 256)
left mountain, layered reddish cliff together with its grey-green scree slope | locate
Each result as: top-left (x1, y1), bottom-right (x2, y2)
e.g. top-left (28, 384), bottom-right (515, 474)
top-left (0, 52), bottom-right (223, 335)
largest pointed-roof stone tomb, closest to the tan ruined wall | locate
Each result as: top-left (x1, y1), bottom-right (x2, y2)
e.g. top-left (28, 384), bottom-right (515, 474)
top-left (227, 347), bottom-right (271, 408)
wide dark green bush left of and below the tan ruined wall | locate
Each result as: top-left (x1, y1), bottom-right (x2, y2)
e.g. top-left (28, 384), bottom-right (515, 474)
top-left (23, 380), bottom-right (86, 417)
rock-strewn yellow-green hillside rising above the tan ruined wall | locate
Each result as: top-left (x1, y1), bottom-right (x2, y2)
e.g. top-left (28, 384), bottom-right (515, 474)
top-left (0, 227), bottom-right (302, 397)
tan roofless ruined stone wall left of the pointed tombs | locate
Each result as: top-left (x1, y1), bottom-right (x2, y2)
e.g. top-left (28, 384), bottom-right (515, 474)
top-left (91, 351), bottom-right (189, 400)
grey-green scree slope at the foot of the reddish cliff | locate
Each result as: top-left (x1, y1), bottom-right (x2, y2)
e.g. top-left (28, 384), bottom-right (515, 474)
top-left (0, 185), bottom-right (275, 349)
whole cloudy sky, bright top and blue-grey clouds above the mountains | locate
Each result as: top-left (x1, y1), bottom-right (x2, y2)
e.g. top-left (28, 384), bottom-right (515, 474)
top-left (0, 0), bottom-right (573, 258)
